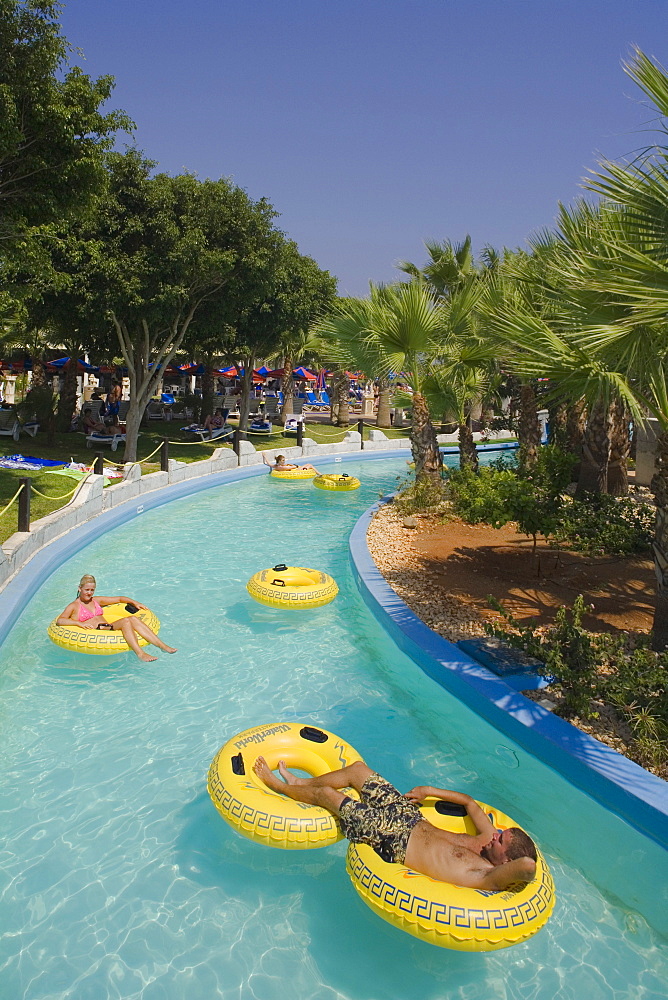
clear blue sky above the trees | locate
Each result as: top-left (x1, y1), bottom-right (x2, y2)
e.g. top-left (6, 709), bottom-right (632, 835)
top-left (61, 0), bottom-right (668, 295)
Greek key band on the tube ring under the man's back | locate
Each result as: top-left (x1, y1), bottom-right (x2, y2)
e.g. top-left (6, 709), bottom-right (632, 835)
top-left (348, 845), bottom-right (553, 930)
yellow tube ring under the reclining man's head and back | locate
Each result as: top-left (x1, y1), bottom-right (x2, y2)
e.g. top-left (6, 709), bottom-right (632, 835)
top-left (346, 799), bottom-right (554, 951)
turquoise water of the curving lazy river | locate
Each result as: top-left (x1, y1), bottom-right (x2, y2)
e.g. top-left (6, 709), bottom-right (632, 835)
top-left (0, 459), bottom-right (668, 1000)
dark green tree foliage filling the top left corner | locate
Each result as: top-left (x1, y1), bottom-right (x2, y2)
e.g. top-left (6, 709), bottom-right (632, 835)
top-left (0, 0), bottom-right (134, 242)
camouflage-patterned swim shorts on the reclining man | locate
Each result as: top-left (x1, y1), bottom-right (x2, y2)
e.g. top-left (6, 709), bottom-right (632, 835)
top-left (339, 774), bottom-right (422, 865)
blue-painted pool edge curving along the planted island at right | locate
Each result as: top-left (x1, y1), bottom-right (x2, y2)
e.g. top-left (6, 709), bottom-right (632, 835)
top-left (349, 497), bottom-right (668, 848)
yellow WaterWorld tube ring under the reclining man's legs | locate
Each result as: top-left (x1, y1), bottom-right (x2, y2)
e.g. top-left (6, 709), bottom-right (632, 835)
top-left (207, 722), bottom-right (362, 850)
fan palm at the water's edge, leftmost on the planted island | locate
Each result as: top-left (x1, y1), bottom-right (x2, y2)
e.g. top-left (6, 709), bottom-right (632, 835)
top-left (318, 281), bottom-right (446, 480)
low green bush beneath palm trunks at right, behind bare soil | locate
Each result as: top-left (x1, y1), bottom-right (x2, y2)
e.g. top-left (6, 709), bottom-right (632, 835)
top-left (555, 493), bottom-right (656, 556)
